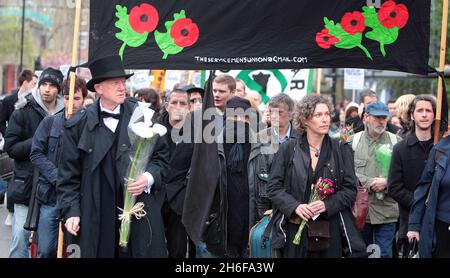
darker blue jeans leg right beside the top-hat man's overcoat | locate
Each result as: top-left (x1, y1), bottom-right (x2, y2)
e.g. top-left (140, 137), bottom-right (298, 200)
top-left (37, 205), bottom-right (59, 258)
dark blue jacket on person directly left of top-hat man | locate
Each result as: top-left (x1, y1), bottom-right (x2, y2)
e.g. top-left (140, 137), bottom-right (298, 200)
top-left (30, 110), bottom-right (65, 205)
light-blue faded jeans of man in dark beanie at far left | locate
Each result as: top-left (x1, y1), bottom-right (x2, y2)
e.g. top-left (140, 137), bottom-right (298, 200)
top-left (9, 204), bottom-right (31, 258)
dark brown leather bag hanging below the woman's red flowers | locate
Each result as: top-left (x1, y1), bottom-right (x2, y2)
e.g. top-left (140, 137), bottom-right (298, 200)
top-left (308, 220), bottom-right (330, 252)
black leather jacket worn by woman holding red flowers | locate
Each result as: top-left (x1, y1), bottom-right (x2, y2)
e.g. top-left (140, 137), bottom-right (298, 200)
top-left (267, 137), bottom-right (366, 256)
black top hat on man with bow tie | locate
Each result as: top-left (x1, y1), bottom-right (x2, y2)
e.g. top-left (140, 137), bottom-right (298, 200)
top-left (86, 55), bottom-right (134, 92)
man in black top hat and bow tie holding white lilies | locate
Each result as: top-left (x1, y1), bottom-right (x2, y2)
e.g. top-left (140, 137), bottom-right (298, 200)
top-left (57, 56), bottom-right (168, 258)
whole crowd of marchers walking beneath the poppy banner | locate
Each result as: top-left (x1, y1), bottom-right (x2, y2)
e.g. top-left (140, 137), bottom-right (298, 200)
top-left (0, 56), bottom-right (450, 258)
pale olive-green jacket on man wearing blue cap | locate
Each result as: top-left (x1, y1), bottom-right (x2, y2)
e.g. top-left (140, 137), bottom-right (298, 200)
top-left (349, 131), bottom-right (401, 224)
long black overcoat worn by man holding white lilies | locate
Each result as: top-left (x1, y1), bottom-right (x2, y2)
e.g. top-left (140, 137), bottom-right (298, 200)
top-left (57, 99), bottom-right (168, 258)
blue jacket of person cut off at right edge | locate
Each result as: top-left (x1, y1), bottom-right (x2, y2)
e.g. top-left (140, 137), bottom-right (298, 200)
top-left (408, 137), bottom-right (450, 258)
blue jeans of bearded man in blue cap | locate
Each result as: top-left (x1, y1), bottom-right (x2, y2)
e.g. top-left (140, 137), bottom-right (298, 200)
top-left (362, 223), bottom-right (395, 258)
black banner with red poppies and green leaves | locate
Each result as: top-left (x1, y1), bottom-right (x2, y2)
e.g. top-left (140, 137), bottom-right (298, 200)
top-left (89, 0), bottom-right (430, 74)
